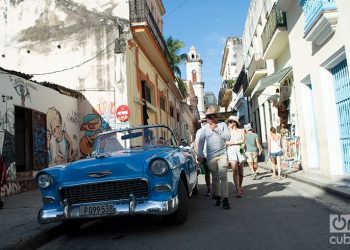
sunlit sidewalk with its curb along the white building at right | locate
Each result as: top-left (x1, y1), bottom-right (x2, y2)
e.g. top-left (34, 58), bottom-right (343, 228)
top-left (259, 162), bottom-right (350, 200)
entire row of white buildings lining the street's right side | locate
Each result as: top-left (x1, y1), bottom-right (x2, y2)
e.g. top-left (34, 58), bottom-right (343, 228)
top-left (241, 0), bottom-right (350, 177)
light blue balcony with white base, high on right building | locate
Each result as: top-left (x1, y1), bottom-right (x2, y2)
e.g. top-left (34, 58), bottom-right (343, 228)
top-left (298, 0), bottom-right (338, 45)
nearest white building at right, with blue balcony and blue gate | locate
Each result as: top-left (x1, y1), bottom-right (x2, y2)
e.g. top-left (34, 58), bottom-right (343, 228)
top-left (277, 0), bottom-right (350, 176)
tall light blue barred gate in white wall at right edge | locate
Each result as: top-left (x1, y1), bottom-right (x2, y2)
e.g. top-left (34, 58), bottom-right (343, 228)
top-left (332, 59), bottom-right (350, 173)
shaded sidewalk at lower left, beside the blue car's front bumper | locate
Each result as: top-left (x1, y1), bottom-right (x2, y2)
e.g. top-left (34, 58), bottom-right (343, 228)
top-left (0, 189), bottom-right (62, 250)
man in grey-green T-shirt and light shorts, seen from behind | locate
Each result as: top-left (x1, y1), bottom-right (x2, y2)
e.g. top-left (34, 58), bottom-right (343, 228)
top-left (244, 123), bottom-right (263, 180)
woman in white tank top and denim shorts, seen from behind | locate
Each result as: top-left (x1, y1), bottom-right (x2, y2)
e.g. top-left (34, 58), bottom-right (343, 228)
top-left (267, 127), bottom-right (283, 180)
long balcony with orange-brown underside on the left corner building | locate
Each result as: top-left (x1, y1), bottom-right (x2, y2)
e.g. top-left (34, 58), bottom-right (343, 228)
top-left (129, 0), bottom-right (175, 82)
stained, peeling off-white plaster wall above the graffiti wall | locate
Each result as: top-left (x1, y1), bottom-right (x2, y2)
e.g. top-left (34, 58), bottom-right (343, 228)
top-left (0, 0), bottom-right (128, 89)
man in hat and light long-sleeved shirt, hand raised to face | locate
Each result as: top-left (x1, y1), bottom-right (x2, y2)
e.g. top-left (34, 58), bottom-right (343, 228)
top-left (198, 107), bottom-right (231, 209)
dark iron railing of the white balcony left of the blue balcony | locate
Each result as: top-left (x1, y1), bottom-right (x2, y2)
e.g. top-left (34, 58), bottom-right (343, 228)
top-left (261, 4), bottom-right (287, 52)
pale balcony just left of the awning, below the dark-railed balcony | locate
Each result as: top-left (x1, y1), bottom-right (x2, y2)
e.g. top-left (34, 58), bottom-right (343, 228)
top-left (244, 53), bottom-right (267, 96)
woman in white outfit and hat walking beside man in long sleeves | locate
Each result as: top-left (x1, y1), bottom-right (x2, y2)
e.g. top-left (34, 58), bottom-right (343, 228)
top-left (226, 115), bottom-right (246, 198)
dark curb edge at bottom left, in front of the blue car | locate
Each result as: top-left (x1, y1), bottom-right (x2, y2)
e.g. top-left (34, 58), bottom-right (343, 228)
top-left (1, 224), bottom-right (63, 250)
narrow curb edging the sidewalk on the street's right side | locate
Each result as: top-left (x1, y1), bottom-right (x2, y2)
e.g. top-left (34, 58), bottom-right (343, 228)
top-left (259, 164), bottom-right (350, 200)
